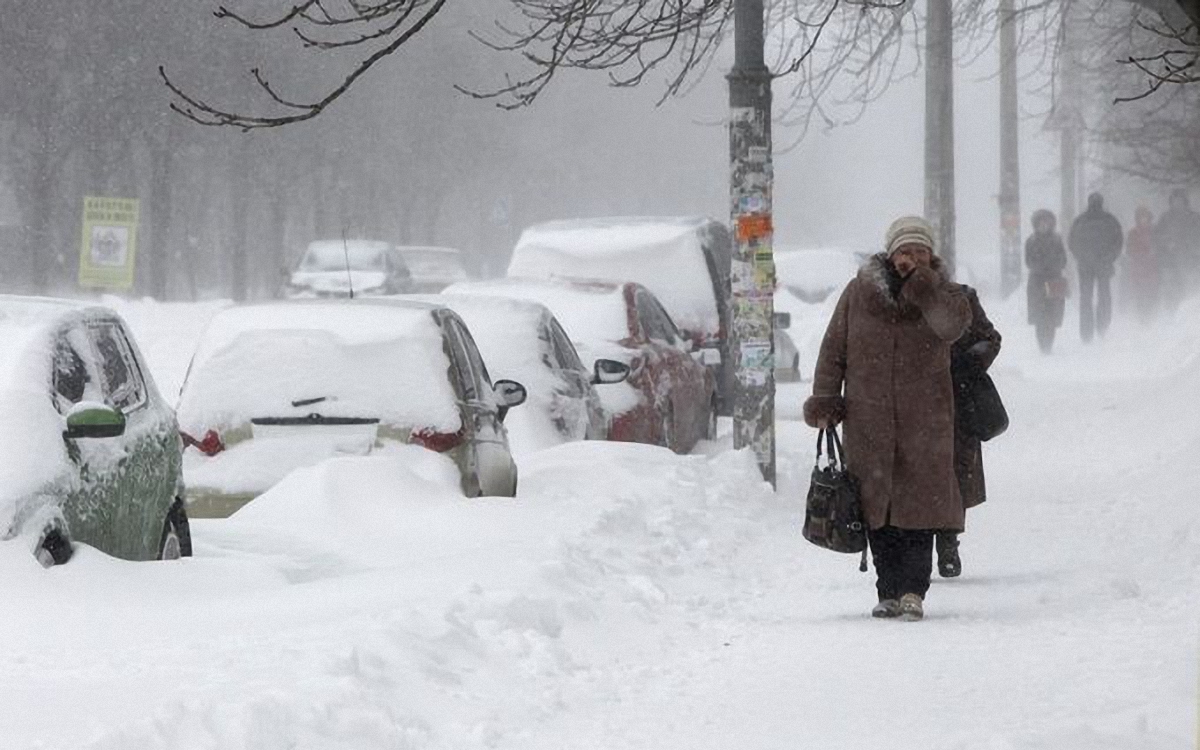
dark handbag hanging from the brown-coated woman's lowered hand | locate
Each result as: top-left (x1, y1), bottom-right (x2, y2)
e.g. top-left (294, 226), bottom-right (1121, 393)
top-left (802, 427), bottom-right (866, 553)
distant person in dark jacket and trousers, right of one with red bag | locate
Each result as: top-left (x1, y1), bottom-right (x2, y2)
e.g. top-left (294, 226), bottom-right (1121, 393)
top-left (1067, 193), bottom-right (1124, 343)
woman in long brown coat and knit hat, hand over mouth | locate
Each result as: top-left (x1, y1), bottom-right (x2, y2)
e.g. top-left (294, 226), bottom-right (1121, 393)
top-left (804, 216), bottom-right (971, 620)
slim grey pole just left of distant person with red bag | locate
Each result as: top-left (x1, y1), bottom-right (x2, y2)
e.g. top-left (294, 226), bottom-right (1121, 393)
top-left (1000, 0), bottom-right (1021, 298)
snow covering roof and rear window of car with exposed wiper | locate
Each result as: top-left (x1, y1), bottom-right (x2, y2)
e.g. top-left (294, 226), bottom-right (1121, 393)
top-left (179, 300), bottom-right (461, 432)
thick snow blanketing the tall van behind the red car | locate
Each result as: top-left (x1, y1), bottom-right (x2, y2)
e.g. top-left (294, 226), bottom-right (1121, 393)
top-left (508, 216), bottom-right (720, 334)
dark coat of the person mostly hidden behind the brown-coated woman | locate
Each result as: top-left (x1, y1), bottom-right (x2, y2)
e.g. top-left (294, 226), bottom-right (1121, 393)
top-left (950, 284), bottom-right (1001, 508)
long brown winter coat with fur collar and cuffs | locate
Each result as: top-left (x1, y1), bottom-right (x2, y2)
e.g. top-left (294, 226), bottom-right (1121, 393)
top-left (804, 254), bottom-right (971, 529)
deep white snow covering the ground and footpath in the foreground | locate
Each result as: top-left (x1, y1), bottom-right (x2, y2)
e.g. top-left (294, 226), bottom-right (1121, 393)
top-left (0, 295), bottom-right (1200, 750)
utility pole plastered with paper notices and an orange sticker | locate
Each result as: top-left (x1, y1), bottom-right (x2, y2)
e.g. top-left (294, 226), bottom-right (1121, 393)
top-left (726, 0), bottom-right (775, 486)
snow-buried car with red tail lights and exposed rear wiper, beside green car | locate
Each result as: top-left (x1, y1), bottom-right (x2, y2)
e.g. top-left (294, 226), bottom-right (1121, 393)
top-left (178, 299), bottom-right (526, 517)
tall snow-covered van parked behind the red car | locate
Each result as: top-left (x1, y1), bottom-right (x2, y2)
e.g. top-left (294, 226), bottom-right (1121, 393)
top-left (508, 216), bottom-right (733, 414)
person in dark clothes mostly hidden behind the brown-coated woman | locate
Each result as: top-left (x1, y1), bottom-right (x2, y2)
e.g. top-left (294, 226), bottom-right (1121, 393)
top-left (935, 284), bottom-right (1001, 578)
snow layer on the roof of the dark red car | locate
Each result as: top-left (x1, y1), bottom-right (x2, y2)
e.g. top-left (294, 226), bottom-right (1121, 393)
top-left (445, 278), bottom-right (629, 346)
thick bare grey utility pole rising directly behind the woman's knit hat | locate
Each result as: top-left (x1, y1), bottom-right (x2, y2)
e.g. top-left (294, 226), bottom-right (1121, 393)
top-left (925, 0), bottom-right (955, 276)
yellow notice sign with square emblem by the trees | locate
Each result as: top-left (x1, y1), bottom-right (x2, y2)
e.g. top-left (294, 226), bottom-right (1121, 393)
top-left (79, 196), bottom-right (138, 289)
